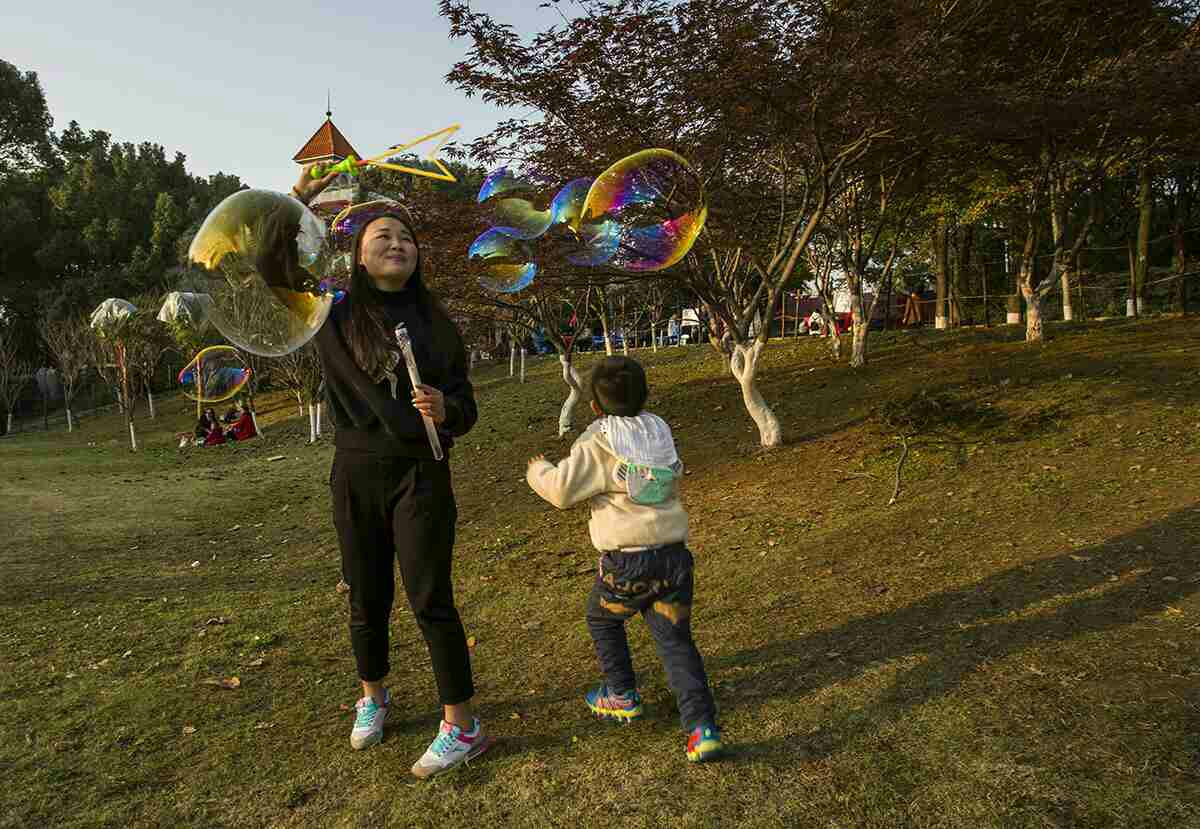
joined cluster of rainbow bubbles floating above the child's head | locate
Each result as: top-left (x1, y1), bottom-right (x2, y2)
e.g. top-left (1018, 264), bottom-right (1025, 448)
top-left (468, 149), bottom-right (708, 294)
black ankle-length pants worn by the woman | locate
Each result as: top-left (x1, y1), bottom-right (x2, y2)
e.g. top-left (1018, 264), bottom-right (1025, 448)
top-left (330, 449), bottom-right (475, 705)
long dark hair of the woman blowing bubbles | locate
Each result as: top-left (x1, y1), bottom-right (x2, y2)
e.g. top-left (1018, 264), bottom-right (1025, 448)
top-left (346, 215), bottom-right (450, 382)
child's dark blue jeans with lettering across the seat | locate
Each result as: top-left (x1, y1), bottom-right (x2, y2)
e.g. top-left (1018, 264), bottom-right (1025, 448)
top-left (588, 543), bottom-right (716, 731)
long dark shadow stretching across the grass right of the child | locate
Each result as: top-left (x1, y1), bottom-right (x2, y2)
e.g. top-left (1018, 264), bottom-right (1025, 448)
top-left (701, 507), bottom-right (1200, 763)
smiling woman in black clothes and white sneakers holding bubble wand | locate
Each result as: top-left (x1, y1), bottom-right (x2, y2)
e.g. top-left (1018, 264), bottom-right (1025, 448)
top-left (292, 169), bottom-right (488, 777)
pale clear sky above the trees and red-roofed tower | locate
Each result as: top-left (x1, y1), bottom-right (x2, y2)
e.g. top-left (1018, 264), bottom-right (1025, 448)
top-left (0, 0), bottom-right (568, 191)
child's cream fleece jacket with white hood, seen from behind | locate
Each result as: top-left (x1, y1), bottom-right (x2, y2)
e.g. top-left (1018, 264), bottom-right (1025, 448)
top-left (526, 412), bottom-right (688, 552)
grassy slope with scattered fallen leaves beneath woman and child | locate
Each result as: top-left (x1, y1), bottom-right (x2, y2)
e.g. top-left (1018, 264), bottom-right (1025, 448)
top-left (0, 319), bottom-right (1200, 828)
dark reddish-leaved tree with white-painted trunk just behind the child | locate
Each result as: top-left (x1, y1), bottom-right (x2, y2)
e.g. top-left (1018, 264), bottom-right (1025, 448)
top-left (440, 0), bottom-right (890, 446)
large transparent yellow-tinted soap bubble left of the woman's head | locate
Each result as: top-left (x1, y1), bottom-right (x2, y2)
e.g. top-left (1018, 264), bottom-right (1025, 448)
top-left (180, 190), bottom-right (334, 356)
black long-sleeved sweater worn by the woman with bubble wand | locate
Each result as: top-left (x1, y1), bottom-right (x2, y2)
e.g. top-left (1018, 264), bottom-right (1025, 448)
top-left (314, 283), bottom-right (479, 458)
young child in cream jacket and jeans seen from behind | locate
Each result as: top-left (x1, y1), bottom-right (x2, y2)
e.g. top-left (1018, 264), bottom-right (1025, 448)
top-left (526, 356), bottom-right (721, 762)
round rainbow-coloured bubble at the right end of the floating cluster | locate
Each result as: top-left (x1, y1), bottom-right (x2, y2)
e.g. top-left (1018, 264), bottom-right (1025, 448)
top-left (581, 150), bottom-right (708, 272)
